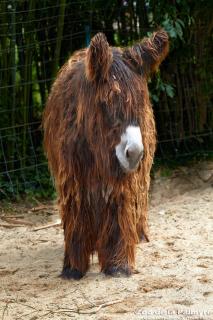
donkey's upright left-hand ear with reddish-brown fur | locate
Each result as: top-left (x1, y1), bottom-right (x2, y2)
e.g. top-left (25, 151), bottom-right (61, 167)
top-left (85, 33), bottom-right (112, 81)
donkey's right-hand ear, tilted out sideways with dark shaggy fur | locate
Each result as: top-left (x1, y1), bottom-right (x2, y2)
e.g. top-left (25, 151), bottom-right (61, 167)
top-left (123, 30), bottom-right (169, 76)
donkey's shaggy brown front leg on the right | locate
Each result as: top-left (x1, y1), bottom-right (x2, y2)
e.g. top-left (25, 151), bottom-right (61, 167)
top-left (98, 198), bottom-right (138, 276)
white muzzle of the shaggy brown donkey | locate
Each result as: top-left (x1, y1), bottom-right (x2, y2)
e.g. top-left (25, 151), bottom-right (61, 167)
top-left (115, 125), bottom-right (144, 172)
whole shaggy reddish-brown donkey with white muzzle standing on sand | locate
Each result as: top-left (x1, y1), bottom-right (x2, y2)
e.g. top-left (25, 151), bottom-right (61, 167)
top-left (43, 30), bottom-right (168, 279)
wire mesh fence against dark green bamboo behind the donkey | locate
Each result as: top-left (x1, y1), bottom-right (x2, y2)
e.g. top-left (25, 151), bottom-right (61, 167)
top-left (0, 0), bottom-right (213, 198)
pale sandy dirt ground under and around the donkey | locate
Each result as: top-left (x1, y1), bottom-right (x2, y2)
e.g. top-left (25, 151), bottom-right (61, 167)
top-left (0, 162), bottom-right (213, 320)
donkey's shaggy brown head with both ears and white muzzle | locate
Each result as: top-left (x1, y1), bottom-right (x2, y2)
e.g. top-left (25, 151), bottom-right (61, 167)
top-left (85, 30), bottom-right (169, 172)
